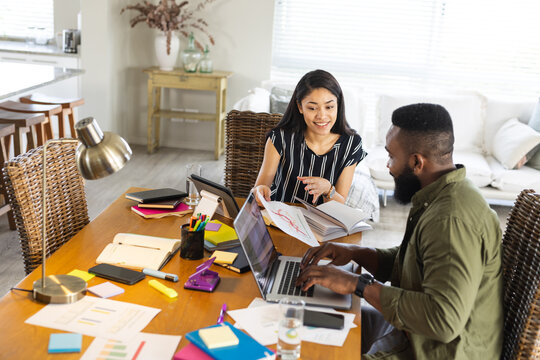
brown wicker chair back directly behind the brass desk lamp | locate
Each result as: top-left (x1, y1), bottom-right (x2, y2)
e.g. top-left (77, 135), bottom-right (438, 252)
top-left (3, 143), bottom-right (89, 274)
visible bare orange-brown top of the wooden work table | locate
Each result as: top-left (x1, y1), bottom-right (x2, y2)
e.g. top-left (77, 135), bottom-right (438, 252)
top-left (0, 188), bottom-right (361, 360)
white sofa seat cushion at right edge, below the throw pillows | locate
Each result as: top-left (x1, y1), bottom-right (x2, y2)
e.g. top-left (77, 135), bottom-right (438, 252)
top-left (486, 156), bottom-right (540, 193)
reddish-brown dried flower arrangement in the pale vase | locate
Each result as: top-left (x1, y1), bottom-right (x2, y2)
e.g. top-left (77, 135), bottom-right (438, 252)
top-left (120, 0), bottom-right (215, 54)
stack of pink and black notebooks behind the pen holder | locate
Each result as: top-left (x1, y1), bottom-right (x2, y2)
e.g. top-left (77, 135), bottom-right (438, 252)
top-left (126, 188), bottom-right (193, 219)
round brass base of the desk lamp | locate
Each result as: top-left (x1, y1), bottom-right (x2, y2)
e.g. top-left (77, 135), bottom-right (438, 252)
top-left (33, 275), bottom-right (86, 304)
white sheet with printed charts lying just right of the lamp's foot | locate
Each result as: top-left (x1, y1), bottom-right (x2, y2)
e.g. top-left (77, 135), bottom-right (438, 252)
top-left (25, 296), bottom-right (161, 340)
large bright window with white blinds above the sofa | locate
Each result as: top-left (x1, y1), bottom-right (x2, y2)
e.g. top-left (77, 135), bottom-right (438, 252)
top-left (271, 0), bottom-right (540, 132)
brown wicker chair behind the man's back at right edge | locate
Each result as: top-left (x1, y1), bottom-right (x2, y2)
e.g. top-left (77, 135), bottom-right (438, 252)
top-left (501, 190), bottom-right (540, 360)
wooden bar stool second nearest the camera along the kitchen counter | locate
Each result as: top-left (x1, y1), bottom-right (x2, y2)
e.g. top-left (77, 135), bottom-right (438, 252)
top-left (0, 110), bottom-right (45, 156)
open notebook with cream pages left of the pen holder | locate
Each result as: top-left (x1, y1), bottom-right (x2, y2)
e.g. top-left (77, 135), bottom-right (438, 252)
top-left (96, 233), bottom-right (180, 270)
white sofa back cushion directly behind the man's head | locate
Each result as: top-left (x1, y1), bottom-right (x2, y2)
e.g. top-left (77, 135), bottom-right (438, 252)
top-left (377, 94), bottom-right (484, 152)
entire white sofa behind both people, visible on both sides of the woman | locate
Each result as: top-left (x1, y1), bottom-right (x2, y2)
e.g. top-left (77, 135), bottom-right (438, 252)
top-left (234, 82), bottom-right (540, 207)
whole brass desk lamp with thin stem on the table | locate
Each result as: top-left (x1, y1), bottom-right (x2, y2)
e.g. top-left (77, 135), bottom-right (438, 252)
top-left (33, 117), bottom-right (131, 304)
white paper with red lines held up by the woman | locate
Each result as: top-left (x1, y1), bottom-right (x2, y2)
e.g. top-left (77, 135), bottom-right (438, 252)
top-left (257, 190), bottom-right (319, 246)
